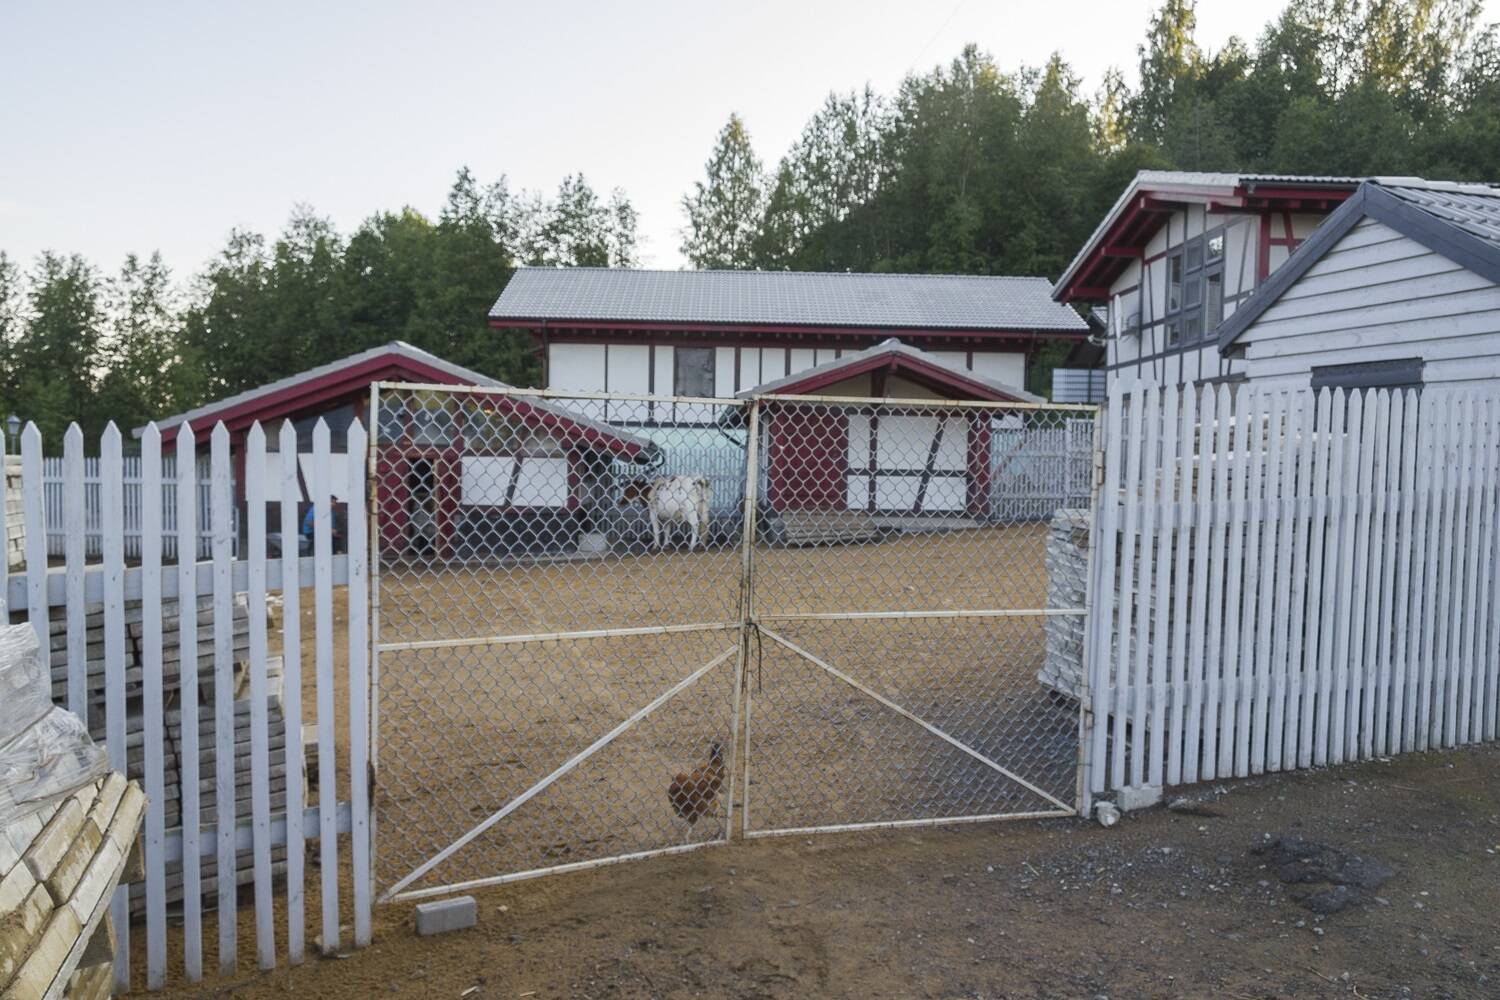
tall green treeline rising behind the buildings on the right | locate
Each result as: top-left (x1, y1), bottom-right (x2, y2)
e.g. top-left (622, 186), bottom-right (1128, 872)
top-left (683, 0), bottom-right (1500, 277)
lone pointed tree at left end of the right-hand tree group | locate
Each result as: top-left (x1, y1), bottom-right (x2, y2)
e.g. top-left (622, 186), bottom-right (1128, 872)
top-left (683, 114), bottom-right (765, 268)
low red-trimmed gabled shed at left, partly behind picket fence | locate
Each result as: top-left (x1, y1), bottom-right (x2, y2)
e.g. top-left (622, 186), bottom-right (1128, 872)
top-left (135, 340), bottom-right (651, 552)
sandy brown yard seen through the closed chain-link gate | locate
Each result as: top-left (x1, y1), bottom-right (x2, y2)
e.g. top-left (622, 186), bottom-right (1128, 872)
top-left (360, 525), bottom-right (1077, 888)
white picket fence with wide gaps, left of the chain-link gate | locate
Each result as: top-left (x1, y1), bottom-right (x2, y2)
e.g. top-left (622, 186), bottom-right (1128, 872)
top-left (0, 421), bottom-right (371, 990)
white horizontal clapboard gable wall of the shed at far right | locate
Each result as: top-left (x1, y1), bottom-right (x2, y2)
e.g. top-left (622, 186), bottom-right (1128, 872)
top-left (1239, 219), bottom-right (1500, 385)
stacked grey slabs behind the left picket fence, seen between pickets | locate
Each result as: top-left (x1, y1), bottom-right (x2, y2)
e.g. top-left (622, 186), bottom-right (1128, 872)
top-left (23, 595), bottom-right (306, 916)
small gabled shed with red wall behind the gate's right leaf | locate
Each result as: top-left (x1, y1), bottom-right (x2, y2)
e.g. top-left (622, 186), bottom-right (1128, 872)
top-left (743, 339), bottom-right (1044, 517)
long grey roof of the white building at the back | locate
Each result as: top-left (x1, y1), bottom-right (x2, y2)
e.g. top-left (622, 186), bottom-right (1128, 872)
top-left (489, 267), bottom-right (1088, 333)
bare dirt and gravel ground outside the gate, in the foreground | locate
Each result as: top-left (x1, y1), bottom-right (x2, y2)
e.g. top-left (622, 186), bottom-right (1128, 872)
top-left (143, 747), bottom-right (1500, 1000)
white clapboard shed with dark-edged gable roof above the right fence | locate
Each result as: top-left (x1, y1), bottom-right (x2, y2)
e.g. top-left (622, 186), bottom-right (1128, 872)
top-left (1217, 178), bottom-right (1500, 388)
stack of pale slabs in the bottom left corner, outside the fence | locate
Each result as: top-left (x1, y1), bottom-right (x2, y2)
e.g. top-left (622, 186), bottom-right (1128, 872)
top-left (0, 772), bottom-right (146, 1000)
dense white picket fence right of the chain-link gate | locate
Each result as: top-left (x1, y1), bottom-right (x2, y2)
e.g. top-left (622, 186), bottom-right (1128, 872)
top-left (1086, 385), bottom-right (1500, 795)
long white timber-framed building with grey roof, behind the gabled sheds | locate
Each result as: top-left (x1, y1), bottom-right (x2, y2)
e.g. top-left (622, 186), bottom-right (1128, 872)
top-left (489, 267), bottom-right (1088, 410)
